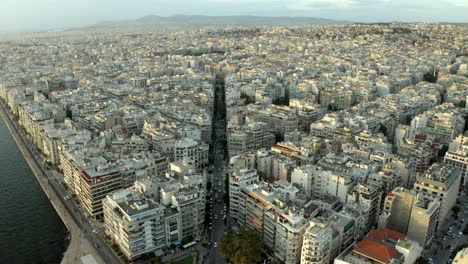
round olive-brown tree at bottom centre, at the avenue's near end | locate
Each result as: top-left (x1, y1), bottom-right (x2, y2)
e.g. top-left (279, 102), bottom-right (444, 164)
top-left (219, 227), bottom-right (261, 264)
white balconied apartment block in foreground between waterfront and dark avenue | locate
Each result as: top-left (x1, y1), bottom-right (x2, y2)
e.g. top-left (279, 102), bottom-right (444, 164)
top-left (102, 161), bottom-right (206, 259)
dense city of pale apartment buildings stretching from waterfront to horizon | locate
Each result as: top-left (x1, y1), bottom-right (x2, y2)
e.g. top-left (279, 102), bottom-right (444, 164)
top-left (0, 20), bottom-right (468, 264)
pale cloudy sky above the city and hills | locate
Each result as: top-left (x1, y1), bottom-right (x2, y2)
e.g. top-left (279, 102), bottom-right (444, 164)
top-left (0, 0), bottom-right (468, 32)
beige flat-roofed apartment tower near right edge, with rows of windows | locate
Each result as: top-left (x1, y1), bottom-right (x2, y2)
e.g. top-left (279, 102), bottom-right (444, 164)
top-left (413, 163), bottom-right (461, 226)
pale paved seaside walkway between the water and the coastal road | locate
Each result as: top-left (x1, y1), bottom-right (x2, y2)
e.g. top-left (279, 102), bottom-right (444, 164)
top-left (0, 99), bottom-right (106, 264)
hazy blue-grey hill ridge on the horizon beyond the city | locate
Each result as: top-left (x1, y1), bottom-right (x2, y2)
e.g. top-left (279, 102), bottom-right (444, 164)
top-left (95, 15), bottom-right (352, 28)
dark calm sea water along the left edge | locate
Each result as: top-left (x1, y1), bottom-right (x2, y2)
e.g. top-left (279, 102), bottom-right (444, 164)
top-left (0, 116), bottom-right (67, 264)
